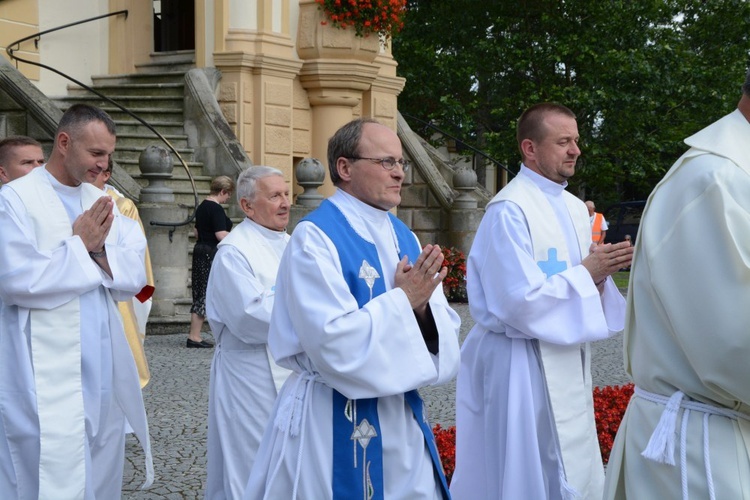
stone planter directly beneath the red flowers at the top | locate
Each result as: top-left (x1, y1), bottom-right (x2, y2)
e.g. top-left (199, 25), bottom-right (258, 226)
top-left (297, 0), bottom-right (380, 63)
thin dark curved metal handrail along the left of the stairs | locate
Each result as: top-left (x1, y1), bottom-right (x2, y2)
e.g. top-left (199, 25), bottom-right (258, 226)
top-left (5, 10), bottom-right (198, 236)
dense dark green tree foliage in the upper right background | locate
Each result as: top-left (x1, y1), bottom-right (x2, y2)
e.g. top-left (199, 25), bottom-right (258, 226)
top-left (393, 0), bottom-right (750, 207)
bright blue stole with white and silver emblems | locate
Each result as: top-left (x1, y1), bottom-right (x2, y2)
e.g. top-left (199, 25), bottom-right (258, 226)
top-left (303, 200), bottom-right (450, 500)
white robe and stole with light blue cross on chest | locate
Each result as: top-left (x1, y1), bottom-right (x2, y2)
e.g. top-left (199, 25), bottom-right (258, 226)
top-left (451, 166), bottom-right (625, 500)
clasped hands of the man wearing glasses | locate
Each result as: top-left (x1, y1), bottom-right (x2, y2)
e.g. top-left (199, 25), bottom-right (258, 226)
top-left (394, 245), bottom-right (448, 313)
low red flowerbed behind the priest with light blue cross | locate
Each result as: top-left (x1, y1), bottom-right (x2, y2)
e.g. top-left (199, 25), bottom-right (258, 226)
top-left (432, 384), bottom-right (633, 483)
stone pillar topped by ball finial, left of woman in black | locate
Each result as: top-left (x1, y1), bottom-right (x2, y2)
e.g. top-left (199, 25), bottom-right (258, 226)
top-left (138, 146), bottom-right (192, 328)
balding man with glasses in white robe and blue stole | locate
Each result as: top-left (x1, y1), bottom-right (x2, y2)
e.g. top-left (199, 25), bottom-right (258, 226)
top-left (245, 119), bottom-right (460, 499)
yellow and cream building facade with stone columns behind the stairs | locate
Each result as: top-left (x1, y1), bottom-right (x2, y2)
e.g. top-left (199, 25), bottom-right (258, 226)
top-left (0, 0), bottom-right (404, 195)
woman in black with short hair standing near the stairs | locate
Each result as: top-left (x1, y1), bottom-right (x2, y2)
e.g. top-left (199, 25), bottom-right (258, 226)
top-left (187, 175), bottom-right (234, 348)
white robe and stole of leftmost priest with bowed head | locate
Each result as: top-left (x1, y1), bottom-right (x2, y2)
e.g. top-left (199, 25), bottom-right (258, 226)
top-left (0, 168), bottom-right (153, 499)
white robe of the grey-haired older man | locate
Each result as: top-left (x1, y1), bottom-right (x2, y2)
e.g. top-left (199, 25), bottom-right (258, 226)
top-left (205, 219), bottom-right (291, 500)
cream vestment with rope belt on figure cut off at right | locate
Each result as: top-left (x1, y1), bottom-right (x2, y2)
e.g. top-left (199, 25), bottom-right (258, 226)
top-left (605, 111), bottom-right (750, 500)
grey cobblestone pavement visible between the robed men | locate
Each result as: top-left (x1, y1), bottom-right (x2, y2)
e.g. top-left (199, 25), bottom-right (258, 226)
top-left (122, 298), bottom-right (629, 500)
